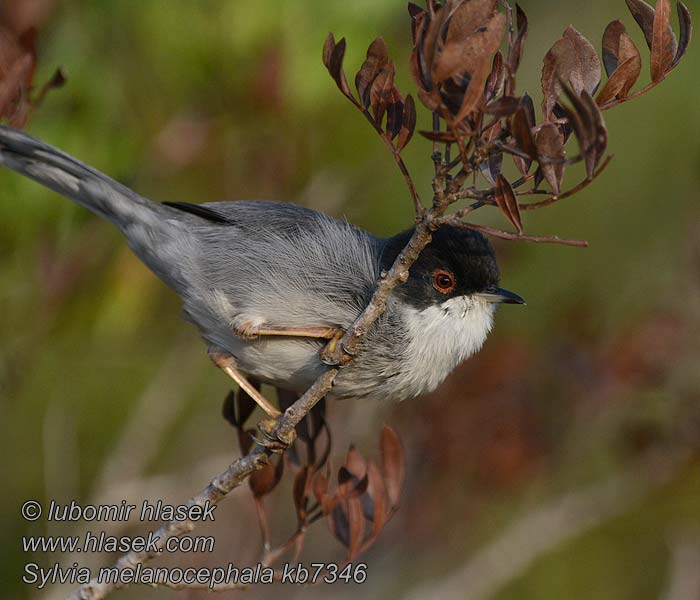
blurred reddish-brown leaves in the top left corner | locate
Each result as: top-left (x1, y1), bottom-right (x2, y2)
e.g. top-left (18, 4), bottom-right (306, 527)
top-left (0, 0), bottom-right (65, 127)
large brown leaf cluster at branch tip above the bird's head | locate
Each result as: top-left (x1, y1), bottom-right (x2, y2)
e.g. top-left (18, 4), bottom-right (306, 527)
top-left (324, 0), bottom-right (692, 245)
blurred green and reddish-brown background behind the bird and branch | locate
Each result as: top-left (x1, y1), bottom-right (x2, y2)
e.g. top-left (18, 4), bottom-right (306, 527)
top-left (0, 0), bottom-right (700, 600)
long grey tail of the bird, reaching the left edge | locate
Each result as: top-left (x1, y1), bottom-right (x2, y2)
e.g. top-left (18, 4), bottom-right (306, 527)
top-left (0, 126), bottom-right (168, 231)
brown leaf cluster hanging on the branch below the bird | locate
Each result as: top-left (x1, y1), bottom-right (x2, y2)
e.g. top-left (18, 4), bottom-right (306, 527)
top-left (223, 384), bottom-right (405, 564)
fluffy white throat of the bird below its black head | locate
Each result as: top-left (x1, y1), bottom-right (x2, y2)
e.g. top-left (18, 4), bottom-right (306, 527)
top-left (401, 296), bottom-right (496, 397)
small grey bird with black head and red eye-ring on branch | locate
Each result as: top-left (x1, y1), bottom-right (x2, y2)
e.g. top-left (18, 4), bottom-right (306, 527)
top-left (0, 126), bottom-right (524, 417)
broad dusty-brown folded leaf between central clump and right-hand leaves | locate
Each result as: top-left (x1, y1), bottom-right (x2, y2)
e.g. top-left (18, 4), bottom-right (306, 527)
top-left (542, 27), bottom-right (601, 120)
